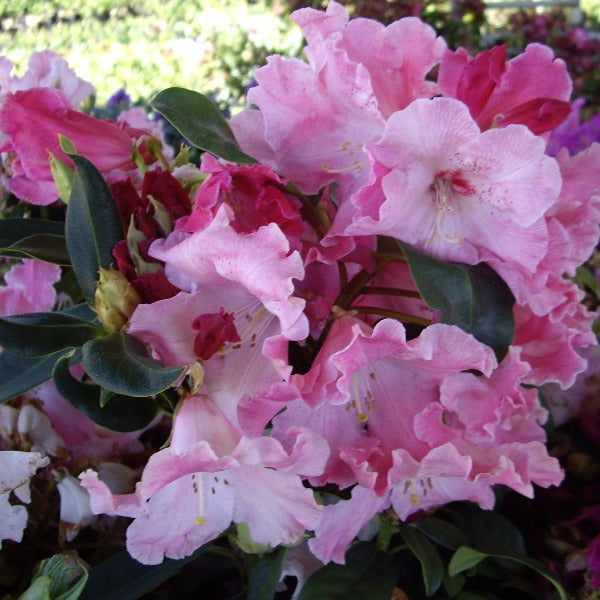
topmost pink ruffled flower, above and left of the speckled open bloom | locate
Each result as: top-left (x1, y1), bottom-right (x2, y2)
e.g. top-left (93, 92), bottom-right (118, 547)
top-left (231, 2), bottom-right (445, 193)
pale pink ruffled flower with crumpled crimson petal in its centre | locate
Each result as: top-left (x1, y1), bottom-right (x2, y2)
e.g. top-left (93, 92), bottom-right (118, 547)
top-left (129, 205), bottom-right (308, 422)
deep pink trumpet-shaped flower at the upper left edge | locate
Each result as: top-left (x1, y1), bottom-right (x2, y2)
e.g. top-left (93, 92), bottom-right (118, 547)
top-left (0, 88), bottom-right (142, 204)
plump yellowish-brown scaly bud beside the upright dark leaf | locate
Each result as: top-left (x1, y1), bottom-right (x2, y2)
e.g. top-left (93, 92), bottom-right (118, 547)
top-left (94, 267), bottom-right (141, 333)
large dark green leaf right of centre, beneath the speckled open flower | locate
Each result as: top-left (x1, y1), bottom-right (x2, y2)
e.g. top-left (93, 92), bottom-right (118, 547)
top-left (398, 241), bottom-right (515, 361)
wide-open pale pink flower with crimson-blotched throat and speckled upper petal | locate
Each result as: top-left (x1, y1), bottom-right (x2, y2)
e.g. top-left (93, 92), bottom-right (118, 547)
top-left (345, 98), bottom-right (561, 271)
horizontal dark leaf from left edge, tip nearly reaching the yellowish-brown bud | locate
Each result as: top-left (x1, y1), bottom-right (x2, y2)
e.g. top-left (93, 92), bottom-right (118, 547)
top-left (0, 312), bottom-right (104, 357)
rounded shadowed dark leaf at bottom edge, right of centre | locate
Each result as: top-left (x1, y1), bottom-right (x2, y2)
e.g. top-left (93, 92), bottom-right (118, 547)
top-left (299, 542), bottom-right (396, 600)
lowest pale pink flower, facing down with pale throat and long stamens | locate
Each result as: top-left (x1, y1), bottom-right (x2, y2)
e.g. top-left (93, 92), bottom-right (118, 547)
top-left (80, 396), bottom-right (329, 564)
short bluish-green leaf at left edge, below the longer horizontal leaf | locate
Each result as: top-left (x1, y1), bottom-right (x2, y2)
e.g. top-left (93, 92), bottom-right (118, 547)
top-left (0, 350), bottom-right (70, 403)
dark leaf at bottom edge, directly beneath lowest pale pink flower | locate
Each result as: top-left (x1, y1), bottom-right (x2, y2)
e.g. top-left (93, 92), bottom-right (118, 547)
top-left (80, 544), bottom-right (210, 600)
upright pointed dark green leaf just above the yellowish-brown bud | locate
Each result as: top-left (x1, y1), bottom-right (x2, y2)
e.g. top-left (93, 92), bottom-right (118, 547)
top-left (65, 154), bottom-right (123, 306)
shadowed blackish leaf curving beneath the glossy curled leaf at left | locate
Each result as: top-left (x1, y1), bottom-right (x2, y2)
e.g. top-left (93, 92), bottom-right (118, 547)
top-left (52, 354), bottom-right (157, 431)
